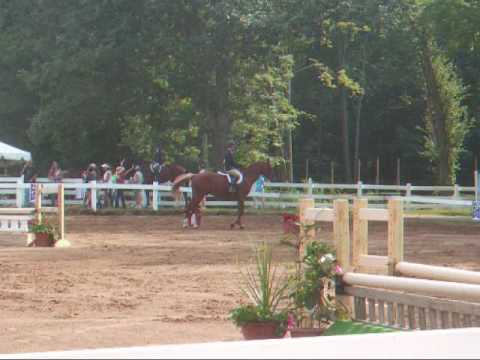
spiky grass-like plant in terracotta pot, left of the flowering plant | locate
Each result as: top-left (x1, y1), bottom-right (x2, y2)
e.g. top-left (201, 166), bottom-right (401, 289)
top-left (229, 244), bottom-right (288, 340)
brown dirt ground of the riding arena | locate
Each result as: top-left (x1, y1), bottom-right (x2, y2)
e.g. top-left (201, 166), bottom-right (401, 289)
top-left (0, 215), bottom-right (480, 353)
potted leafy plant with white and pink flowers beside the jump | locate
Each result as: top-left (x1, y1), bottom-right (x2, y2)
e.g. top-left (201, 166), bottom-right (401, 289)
top-left (289, 241), bottom-right (341, 337)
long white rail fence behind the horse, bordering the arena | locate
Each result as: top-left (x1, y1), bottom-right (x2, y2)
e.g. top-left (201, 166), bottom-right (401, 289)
top-left (0, 172), bottom-right (480, 211)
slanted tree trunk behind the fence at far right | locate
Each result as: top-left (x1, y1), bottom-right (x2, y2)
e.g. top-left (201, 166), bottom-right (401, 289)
top-left (421, 35), bottom-right (452, 185)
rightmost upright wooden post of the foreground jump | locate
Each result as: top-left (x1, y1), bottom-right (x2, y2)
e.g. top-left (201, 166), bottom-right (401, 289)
top-left (388, 199), bottom-right (403, 275)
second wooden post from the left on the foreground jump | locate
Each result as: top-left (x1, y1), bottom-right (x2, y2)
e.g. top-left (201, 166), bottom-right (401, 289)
top-left (333, 199), bottom-right (351, 272)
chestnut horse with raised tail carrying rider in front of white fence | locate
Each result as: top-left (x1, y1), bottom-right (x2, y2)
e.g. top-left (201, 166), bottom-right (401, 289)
top-left (172, 161), bottom-right (273, 229)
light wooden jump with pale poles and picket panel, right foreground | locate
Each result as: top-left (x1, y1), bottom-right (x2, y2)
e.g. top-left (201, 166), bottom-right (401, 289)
top-left (299, 198), bottom-right (480, 330)
